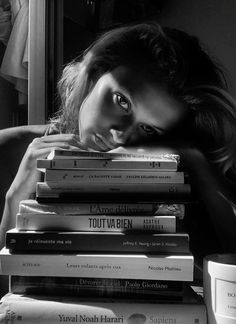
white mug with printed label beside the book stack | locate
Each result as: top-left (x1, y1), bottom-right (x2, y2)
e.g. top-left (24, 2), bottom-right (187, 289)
top-left (203, 254), bottom-right (236, 324)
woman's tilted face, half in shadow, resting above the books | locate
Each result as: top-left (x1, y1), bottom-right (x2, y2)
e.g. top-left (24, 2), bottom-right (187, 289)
top-left (78, 66), bottom-right (186, 151)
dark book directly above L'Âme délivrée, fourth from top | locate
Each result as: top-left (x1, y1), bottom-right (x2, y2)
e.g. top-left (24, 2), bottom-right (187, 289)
top-left (36, 182), bottom-right (191, 202)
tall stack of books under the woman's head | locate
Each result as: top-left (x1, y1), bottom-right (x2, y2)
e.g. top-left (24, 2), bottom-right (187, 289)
top-left (0, 150), bottom-right (206, 324)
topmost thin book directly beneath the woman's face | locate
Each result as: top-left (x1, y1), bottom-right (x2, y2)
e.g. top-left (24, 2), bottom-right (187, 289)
top-left (47, 149), bottom-right (180, 163)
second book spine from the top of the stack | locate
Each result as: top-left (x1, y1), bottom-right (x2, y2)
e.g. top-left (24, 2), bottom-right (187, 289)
top-left (37, 159), bottom-right (177, 171)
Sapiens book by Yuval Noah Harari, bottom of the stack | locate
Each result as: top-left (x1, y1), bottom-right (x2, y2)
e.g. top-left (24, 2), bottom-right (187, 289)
top-left (0, 293), bottom-right (207, 324)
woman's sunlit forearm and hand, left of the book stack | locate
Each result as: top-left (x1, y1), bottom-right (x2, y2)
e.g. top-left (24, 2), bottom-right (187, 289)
top-left (0, 134), bottom-right (89, 248)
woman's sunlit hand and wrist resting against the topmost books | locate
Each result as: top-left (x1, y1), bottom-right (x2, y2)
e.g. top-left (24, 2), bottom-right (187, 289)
top-left (8, 134), bottom-right (86, 200)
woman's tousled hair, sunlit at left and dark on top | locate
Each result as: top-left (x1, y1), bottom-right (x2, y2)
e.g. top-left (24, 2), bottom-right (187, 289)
top-left (52, 22), bottom-right (236, 171)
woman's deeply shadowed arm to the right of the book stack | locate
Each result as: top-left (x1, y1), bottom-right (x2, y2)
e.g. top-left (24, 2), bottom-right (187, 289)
top-left (181, 148), bottom-right (236, 253)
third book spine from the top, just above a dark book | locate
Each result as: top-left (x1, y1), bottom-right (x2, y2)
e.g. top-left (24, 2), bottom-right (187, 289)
top-left (45, 169), bottom-right (184, 187)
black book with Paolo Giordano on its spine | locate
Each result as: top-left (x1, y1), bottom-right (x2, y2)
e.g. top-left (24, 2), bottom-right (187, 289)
top-left (9, 276), bottom-right (184, 300)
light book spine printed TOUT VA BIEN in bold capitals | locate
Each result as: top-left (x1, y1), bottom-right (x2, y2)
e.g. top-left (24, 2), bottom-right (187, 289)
top-left (16, 213), bottom-right (176, 233)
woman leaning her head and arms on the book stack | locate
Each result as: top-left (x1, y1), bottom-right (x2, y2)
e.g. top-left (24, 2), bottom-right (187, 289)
top-left (1, 23), bottom-right (236, 251)
